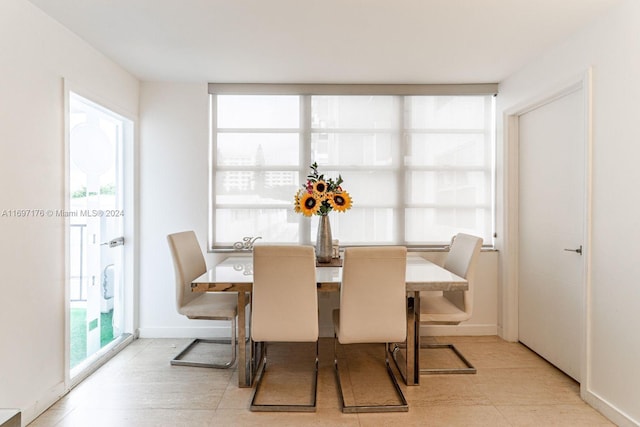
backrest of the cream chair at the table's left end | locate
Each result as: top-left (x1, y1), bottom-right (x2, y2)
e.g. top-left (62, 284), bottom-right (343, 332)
top-left (167, 231), bottom-right (207, 314)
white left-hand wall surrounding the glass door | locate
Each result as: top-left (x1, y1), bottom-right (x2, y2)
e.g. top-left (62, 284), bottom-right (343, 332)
top-left (0, 0), bottom-right (138, 421)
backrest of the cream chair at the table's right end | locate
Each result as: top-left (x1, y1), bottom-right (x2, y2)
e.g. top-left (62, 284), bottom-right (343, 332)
top-left (442, 233), bottom-right (482, 316)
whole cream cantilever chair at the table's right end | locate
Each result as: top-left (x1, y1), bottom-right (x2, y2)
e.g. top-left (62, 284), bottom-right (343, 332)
top-left (420, 233), bottom-right (482, 374)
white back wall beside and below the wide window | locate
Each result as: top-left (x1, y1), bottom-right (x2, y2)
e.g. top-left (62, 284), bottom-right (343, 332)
top-left (140, 83), bottom-right (498, 337)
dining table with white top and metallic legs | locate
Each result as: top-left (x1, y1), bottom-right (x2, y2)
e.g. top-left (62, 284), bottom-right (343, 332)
top-left (191, 253), bottom-right (469, 387)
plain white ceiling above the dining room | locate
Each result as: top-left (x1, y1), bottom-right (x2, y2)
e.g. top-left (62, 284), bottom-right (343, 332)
top-left (30, 0), bottom-right (620, 83)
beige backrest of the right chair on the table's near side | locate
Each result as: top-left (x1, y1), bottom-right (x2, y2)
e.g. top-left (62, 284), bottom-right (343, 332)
top-left (338, 246), bottom-right (407, 344)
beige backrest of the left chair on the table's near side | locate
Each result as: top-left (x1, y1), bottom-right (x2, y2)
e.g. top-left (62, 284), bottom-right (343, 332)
top-left (251, 245), bottom-right (318, 342)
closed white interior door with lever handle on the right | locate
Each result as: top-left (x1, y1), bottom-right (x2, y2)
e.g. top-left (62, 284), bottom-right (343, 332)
top-left (518, 88), bottom-right (586, 381)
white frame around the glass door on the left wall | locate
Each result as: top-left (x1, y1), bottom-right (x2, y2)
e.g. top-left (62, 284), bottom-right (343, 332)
top-left (62, 78), bottom-right (139, 391)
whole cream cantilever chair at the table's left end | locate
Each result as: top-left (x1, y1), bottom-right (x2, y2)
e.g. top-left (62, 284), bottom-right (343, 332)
top-left (167, 231), bottom-right (238, 368)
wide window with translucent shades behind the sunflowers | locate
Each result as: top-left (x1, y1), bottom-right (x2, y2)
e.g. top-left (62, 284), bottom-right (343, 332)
top-left (209, 84), bottom-right (495, 249)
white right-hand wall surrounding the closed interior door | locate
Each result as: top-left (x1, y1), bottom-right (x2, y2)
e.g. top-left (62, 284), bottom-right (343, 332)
top-left (498, 0), bottom-right (640, 425)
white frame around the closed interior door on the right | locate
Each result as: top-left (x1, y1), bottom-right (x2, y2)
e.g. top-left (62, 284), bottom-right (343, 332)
top-left (501, 68), bottom-right (593, 392)
